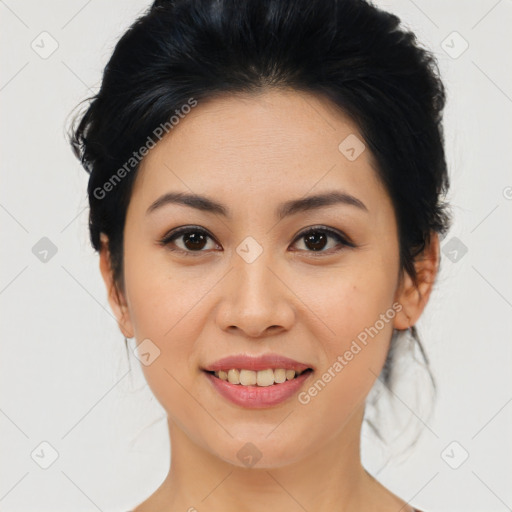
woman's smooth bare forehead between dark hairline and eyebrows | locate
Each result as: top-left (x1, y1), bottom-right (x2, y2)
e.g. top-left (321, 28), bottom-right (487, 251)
top-left (132, 90), bottom-right (383, 213)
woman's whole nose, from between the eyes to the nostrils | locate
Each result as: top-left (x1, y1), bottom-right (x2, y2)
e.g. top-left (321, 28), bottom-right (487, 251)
top-left (217, 237), bottom-right (294, 336)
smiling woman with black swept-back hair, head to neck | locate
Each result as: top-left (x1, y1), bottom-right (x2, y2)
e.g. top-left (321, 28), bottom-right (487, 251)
top-left (68, 0), bottom-right (448, 512)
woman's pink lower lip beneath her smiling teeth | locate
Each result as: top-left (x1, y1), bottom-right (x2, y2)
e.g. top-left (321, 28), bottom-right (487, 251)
top-left (205, 370), bottom-right (313, 409)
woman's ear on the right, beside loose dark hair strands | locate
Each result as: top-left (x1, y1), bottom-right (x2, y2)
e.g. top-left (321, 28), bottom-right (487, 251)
top-left (393, 232), bottom-right (440, 330)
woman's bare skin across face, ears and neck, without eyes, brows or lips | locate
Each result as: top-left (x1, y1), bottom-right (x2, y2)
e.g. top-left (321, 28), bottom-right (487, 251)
top-left (100, 90), bottom-right (439, 512)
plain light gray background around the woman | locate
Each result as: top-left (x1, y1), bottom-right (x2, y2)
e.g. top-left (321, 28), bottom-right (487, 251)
top-left (0, 0), bottom-right (512, 512)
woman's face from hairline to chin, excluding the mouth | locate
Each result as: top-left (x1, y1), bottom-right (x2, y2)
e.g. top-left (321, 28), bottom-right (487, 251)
top-left (102, 91), bottom-right (414, 467)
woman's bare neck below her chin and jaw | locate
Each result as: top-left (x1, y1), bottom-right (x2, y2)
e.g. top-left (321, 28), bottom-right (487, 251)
top-left (150, 405), bottom-right (394, 512)
